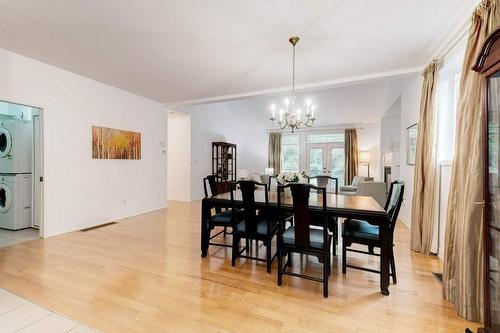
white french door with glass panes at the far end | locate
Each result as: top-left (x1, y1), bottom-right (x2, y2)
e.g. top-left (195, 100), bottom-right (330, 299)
top-left (307, 143), bottom-right (345, 190)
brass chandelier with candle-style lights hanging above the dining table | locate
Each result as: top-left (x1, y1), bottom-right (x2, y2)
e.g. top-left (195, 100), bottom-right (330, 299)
top-left (269, 36), bottom-right (316, 133)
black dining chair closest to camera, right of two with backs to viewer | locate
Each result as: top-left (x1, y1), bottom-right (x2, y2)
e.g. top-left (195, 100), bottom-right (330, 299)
top-left (278, 184), bottom-right (332, 297)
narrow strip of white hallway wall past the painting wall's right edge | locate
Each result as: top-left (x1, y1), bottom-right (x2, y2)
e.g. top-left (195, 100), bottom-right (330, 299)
top-left (167, 112), bottom-right (191, 201)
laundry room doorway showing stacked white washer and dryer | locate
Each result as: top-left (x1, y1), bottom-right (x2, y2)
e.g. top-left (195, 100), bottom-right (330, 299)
top-left (0, 100), bottom-right (43, 247)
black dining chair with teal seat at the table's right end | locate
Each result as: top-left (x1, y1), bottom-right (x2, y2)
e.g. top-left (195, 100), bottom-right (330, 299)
top-left (342, 181), bottom-right (405, 283)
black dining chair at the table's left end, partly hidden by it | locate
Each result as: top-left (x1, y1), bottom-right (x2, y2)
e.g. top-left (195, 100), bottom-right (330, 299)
top-left (203, 175), bottom-right (233, 247)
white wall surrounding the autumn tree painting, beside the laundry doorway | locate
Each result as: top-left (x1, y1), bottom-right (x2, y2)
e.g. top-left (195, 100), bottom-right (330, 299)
top-left (0, 49), bottom-right (167, 236)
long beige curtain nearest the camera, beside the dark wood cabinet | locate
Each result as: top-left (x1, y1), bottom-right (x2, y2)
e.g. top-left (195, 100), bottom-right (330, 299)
top-left (443, 0), bottom-right (500, 321)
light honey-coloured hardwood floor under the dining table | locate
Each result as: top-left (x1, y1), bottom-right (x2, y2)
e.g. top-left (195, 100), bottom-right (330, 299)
top-left (0, 202), bottom-right (478, 333)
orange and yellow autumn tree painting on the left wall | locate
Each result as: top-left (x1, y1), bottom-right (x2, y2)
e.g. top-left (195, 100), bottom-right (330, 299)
top-left (92, 126), bottom-right (141, 160)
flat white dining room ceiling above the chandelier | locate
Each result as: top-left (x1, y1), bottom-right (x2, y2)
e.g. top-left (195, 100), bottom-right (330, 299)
top-left (0, 0), bottom-right (478, 103)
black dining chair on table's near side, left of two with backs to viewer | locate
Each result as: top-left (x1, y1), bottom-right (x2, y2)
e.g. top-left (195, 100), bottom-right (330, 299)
top-left (231, 180), bottom-right (278, 273)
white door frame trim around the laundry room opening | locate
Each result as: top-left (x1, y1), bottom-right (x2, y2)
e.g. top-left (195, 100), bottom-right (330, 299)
top-left (0, 98), bottom-right (45, 238)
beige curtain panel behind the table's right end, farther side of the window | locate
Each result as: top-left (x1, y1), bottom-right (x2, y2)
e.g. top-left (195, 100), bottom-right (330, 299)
top-left (410, 60), bottom-right (437, 254)
